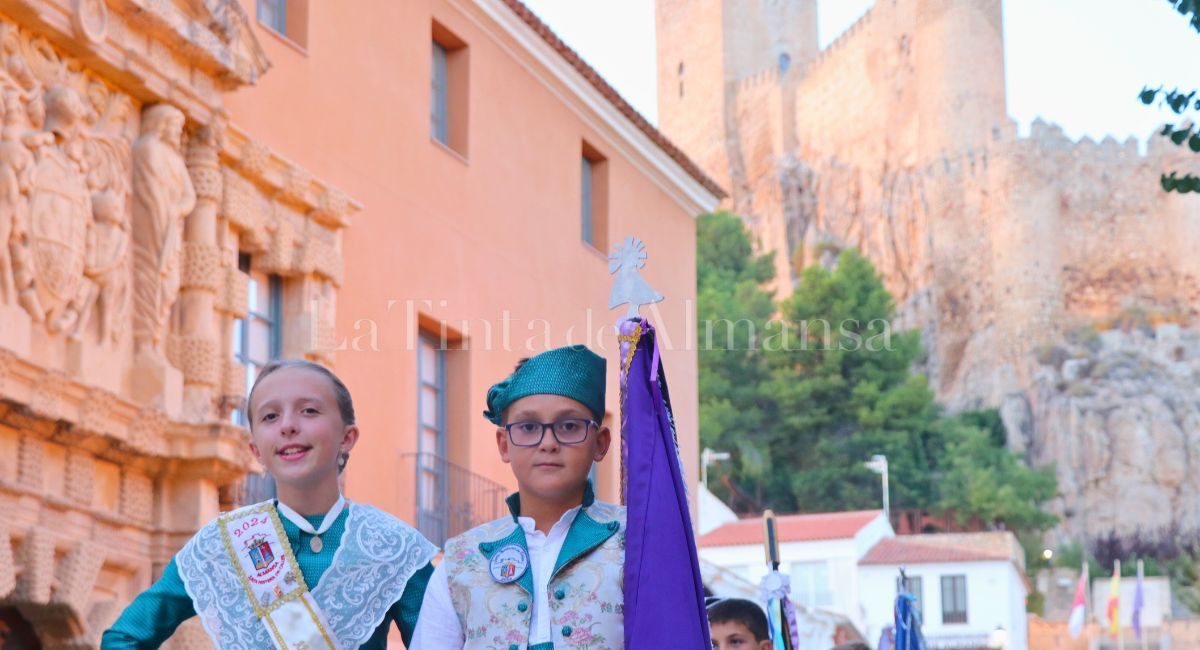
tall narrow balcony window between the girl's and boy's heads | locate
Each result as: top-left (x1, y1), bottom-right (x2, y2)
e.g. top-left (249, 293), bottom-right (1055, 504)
top-left (416, 336), bottom-right (449, 540)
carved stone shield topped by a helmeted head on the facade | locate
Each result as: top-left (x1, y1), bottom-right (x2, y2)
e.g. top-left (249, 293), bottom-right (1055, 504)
top-left (12, 86), bottom-right (91, 332)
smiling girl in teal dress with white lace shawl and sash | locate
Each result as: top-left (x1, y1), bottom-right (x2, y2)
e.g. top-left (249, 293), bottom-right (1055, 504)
top-left (101, 360), bottom-right (437, 650)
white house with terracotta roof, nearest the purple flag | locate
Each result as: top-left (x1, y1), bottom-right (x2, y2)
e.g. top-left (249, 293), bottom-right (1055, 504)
top-left (698, 510), bottom-right (894, 631)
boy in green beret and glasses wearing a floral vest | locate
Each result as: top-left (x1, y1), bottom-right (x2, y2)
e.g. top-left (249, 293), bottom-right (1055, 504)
top-left (413, 345), bottom-right (625, 650)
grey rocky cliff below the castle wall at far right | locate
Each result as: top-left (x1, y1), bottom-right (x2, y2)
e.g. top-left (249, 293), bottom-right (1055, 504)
top-left (1017, 324), bottom-right (1200, 540)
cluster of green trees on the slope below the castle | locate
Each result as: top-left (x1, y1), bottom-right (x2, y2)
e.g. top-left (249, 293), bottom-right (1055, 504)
top-left (697, 221), bottom-right (1056, 530)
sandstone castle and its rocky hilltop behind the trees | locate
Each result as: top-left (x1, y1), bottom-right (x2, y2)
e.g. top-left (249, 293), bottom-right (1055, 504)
top-left (656, 0), bottom-right (1200, 538)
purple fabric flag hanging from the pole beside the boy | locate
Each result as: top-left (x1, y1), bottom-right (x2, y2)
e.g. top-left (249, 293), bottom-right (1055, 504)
top-left (620, 319), bottom-right (713, 650)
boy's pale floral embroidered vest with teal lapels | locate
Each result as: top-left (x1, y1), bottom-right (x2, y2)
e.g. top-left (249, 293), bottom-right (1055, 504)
top-left (443, 501), bottom-right (625, 650)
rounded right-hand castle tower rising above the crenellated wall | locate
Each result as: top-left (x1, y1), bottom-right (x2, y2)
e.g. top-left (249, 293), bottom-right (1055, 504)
top-left (916, 0), bottom-right (1008, 160)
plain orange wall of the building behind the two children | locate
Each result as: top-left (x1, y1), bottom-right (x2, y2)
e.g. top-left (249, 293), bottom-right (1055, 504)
top-left (227, 0), bottom-right (700, 520)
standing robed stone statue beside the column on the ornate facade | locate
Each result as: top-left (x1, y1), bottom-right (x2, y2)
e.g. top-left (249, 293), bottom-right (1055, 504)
top-left (133, 104), bottom-right (196, 360)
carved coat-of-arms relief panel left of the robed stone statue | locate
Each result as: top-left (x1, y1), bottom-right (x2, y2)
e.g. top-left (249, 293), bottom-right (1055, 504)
top-left (0, 24), bottom-right (133, 343)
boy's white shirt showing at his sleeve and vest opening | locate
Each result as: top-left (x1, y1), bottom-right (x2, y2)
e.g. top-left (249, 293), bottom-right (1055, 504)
top-left (412, 506), bottom-right (582, 650)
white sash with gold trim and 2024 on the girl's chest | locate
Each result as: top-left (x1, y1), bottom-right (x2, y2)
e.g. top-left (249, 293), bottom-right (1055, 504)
top-left (220, 504), bottom-right (340, 650)
